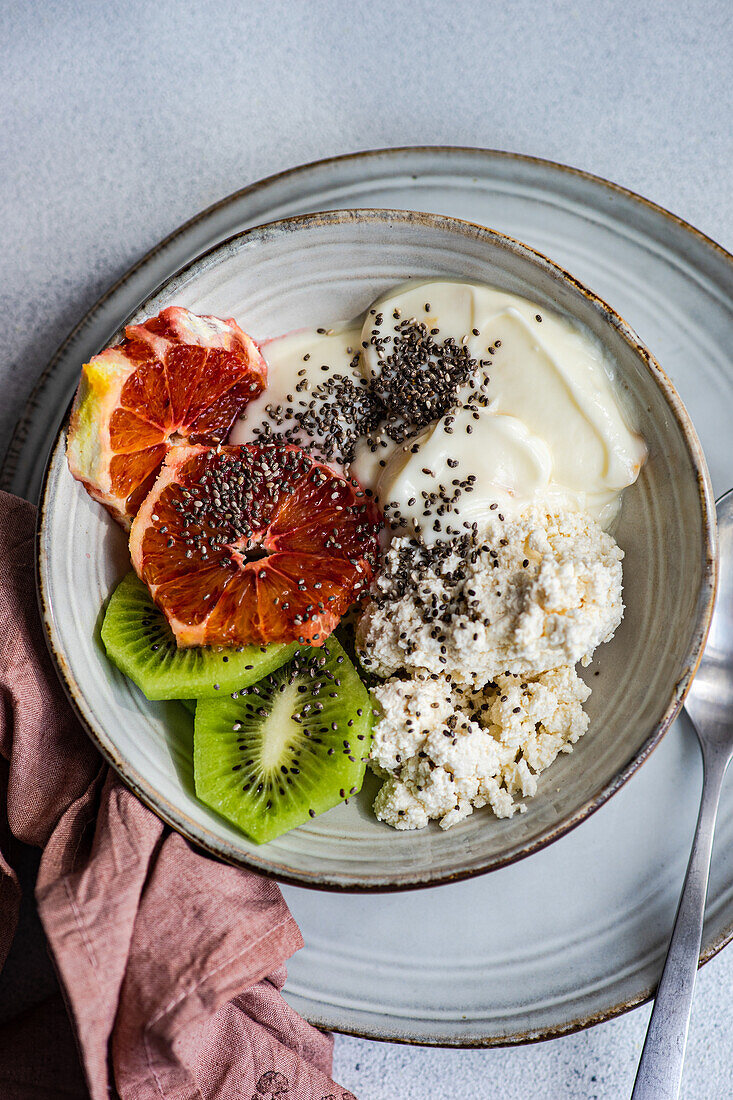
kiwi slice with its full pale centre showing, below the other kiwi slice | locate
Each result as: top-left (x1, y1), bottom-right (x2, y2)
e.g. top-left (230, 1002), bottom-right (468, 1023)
top-left (194, 637), bottom-right (372, 844)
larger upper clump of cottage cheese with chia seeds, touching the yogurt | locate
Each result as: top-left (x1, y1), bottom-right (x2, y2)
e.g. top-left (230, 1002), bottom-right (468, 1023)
top-left (357, 508), bottom-right (623, 688)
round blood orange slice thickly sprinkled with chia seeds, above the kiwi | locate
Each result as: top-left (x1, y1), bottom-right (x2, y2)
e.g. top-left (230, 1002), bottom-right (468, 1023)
top-left (130, 443), bottom-right (382, 646)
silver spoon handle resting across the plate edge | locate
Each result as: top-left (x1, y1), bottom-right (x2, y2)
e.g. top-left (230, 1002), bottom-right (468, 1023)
top-left (632, 752), bottom-right (727, 1100)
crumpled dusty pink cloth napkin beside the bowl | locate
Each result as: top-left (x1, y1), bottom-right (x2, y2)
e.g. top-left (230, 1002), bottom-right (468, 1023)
top-left (0, 493), bottom-right (353, 1100)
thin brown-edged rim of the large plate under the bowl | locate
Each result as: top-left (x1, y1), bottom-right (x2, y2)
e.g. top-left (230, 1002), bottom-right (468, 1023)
top-left (7, 145), bottom-right (733, 1047)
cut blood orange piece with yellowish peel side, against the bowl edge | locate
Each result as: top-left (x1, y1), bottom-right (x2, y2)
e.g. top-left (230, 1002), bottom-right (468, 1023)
top-left (66, 306), bottom-right (267, 527)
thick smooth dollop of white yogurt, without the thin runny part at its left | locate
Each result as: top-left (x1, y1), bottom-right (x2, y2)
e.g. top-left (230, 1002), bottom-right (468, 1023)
top-left (353, 282), bottom-right (646, 540)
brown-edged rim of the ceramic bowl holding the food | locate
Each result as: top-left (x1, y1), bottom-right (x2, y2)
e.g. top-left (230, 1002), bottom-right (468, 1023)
top-left (35, 208), bottom-right (718, 893)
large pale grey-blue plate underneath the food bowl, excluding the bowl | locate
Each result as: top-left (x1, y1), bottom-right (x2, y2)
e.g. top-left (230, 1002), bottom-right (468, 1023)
top-left (3, 150), bottom-right (733, 1044)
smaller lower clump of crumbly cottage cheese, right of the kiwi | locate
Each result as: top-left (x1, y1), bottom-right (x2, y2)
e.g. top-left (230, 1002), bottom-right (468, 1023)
top-left (371, 666), bottom-right (590, 829)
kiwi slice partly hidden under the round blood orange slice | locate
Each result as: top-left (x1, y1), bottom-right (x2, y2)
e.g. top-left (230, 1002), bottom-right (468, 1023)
top-left (101, 572), bottom-right (298, 700)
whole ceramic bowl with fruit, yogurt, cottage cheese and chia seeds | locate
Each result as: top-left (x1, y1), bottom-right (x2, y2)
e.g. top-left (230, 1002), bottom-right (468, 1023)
top-left (37, 210), bottom-right (716, 890)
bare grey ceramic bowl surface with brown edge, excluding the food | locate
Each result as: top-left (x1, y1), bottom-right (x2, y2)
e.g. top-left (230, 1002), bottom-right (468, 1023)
top-left (37, 210), bottom-right (716, 890)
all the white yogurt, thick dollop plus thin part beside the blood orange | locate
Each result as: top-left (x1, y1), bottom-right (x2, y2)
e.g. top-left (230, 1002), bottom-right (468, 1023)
top-left (231, 282), bottom-right (646, 541)
